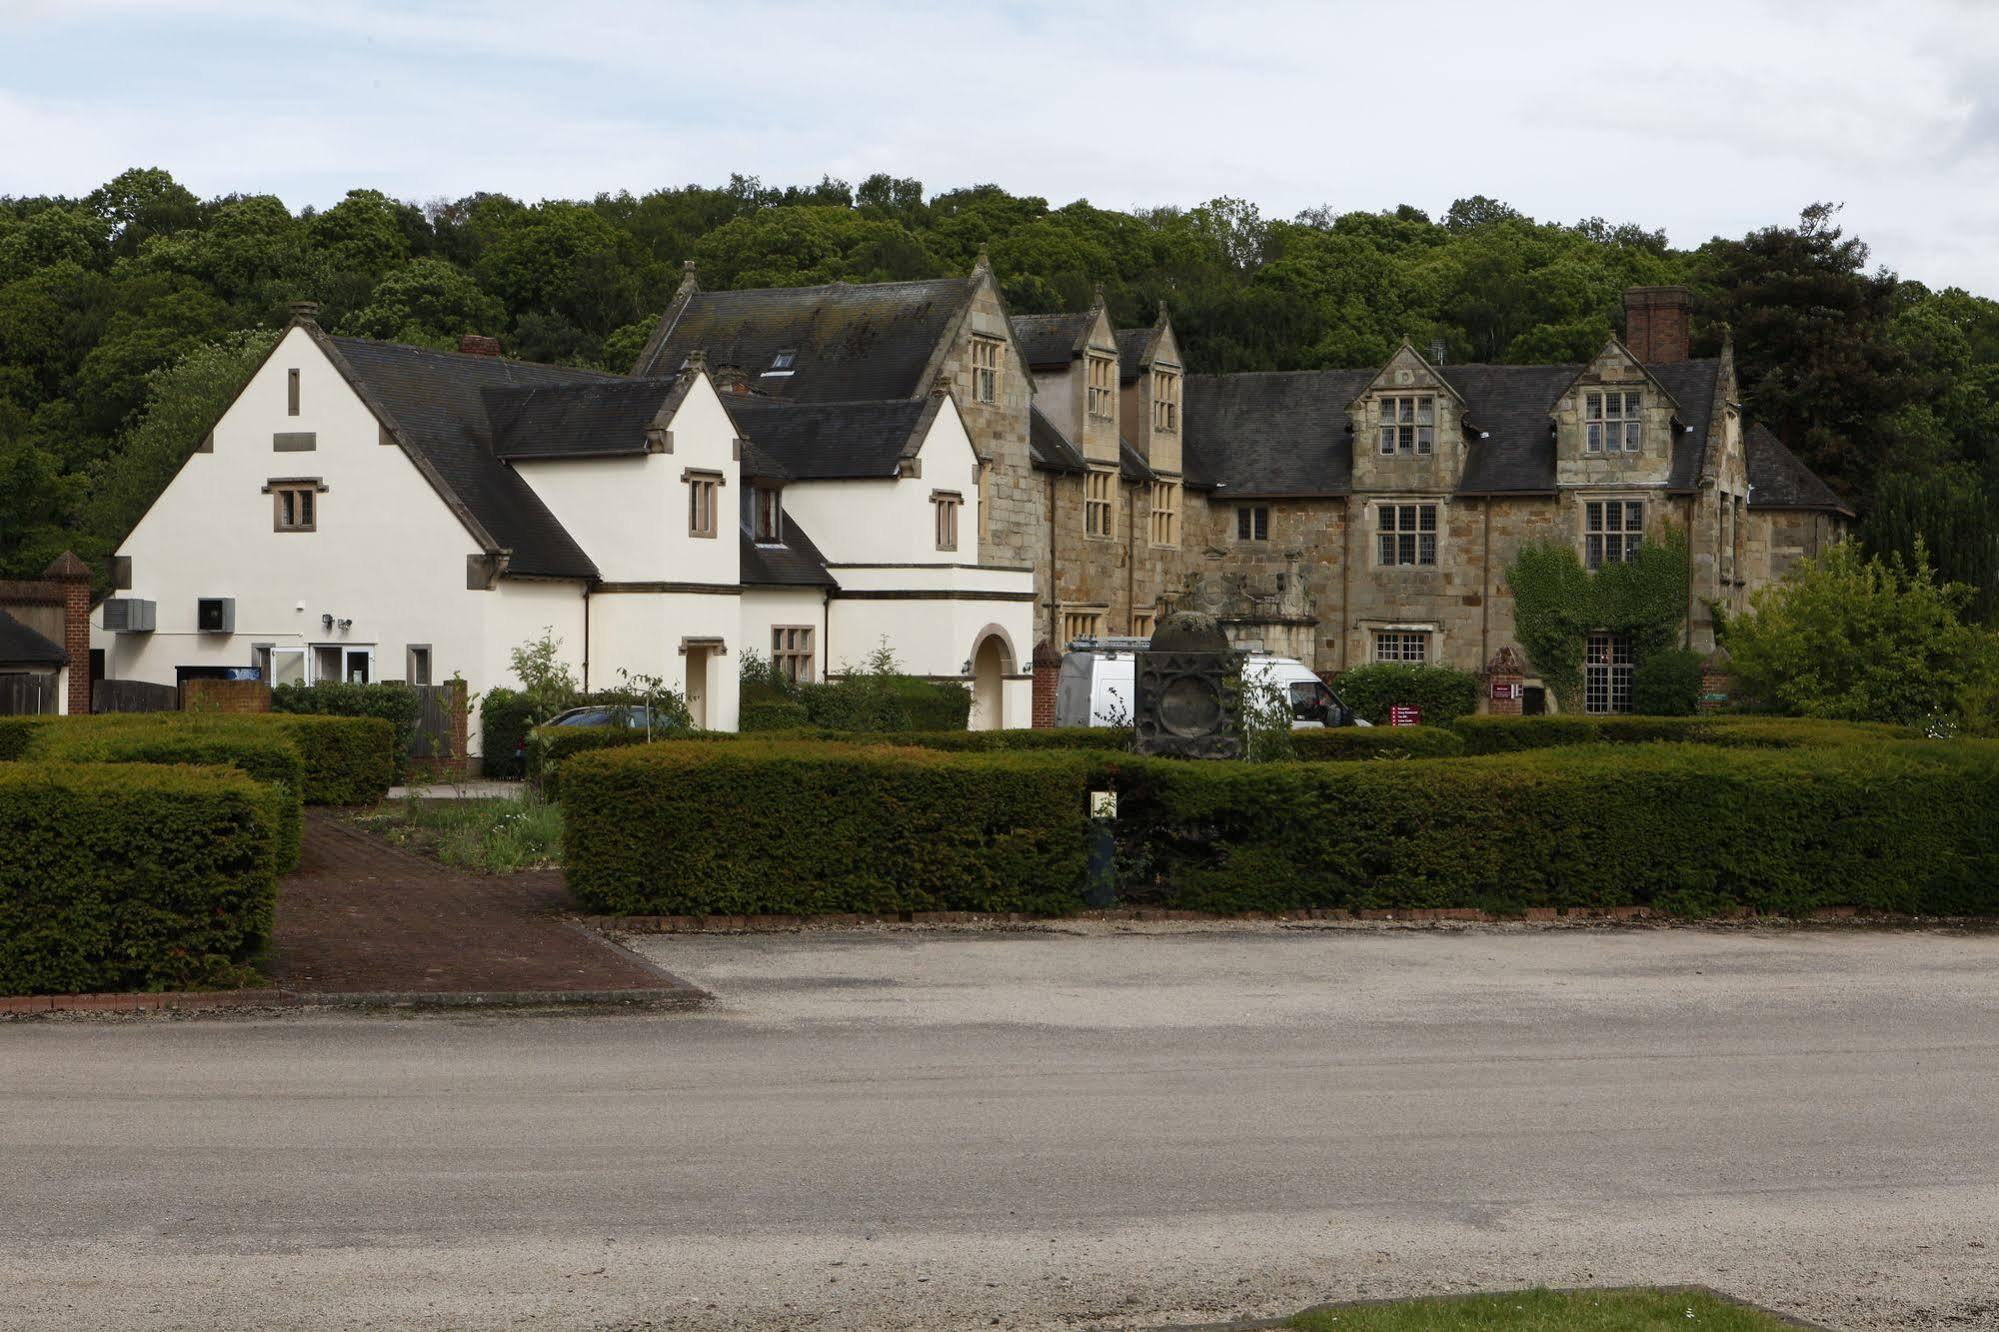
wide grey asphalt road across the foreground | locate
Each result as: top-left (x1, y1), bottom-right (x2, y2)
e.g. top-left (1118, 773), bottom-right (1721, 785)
top-left (0, 928), bottom-right (1999, 1330)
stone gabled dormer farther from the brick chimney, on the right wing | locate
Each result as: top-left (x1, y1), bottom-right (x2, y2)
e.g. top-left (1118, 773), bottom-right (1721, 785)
top-left (1347, 338), bottom-right (1465, 494)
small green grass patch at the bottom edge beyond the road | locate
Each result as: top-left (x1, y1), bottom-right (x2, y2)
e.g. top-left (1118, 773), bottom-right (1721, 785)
top-left (1285, 1290), bottom-right (1795, 1332)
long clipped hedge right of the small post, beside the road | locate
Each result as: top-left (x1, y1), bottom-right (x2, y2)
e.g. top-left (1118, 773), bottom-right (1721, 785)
top-left (1111, 742), bottom-right (1999, 914)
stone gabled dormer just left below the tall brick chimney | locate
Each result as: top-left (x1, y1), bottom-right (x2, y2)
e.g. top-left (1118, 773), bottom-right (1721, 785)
top-left (1551, 338), bottom-right (1681, 486)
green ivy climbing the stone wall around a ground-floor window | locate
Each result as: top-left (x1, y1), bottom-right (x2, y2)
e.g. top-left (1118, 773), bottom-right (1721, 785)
top-left (1505, 528), bottom-right (1687, 710)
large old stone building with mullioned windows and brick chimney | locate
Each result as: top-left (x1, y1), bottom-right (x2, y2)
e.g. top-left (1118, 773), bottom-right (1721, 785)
top-left (634, 264), bottom-right (1851, 710)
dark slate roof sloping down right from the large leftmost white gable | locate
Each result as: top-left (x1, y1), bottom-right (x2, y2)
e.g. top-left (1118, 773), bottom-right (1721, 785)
top-left (322, 334), bottom-right (618, 578)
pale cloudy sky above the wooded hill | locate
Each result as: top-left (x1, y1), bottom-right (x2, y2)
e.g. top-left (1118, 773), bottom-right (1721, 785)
top-left (0, 0), bottom-right (1999, 296)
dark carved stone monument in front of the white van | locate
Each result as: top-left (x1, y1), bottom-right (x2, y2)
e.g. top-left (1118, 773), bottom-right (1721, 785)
top-left (1135, 610), bottom-right (1243, 758)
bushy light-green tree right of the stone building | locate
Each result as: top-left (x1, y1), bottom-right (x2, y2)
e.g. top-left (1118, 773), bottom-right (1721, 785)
top-left (1719, 542), bottom-right (1999, 722)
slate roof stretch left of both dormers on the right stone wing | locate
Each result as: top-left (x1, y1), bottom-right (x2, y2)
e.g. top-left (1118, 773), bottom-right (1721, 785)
top-left (1181, 370), bottom-right (1375, 496)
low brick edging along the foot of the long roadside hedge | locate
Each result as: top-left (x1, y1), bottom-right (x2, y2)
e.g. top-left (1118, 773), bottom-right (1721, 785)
top-left (578, 906), bottom-right (1917, 934)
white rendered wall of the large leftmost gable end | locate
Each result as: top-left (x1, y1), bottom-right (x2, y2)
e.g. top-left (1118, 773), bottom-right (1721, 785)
top-left (92, 328), bottom-right (539, 740)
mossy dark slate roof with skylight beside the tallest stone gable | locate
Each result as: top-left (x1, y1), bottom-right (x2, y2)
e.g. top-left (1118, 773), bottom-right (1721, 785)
top-left (632, 278), bottom-right (978, 402)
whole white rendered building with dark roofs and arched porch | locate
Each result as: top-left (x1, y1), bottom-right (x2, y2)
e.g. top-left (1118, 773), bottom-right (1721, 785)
top-left (92, 318), bottom-right (1033, 748)
